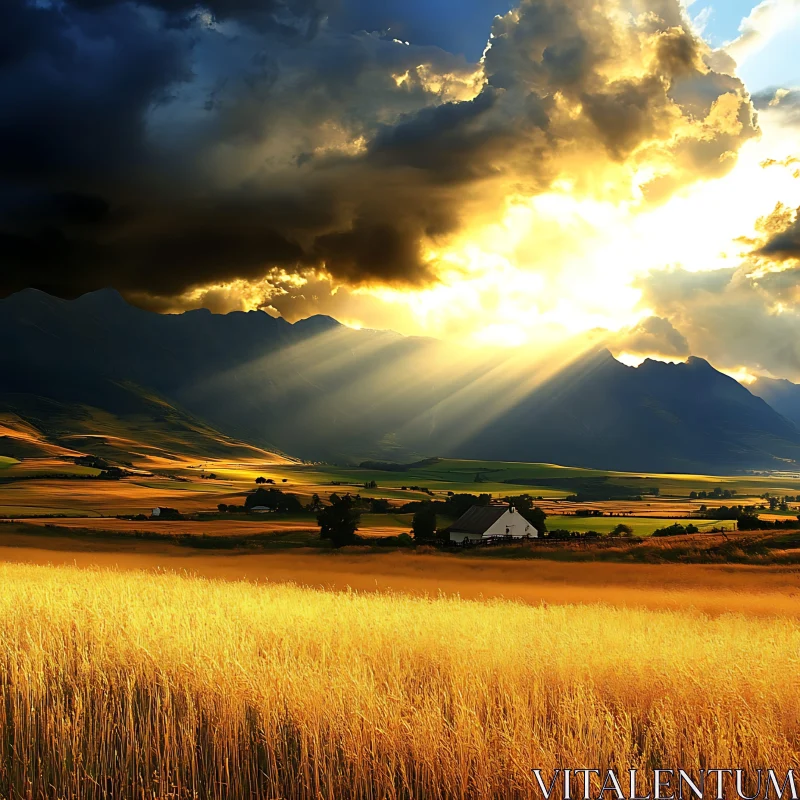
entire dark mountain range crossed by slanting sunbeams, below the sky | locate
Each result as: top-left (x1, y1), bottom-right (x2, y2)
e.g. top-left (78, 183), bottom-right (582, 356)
top-left (0, 289), bottom-right (800, 472)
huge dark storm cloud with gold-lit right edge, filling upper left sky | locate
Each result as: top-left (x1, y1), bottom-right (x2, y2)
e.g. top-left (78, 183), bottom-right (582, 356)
top-left (0, 0), bottom-right (755, 304)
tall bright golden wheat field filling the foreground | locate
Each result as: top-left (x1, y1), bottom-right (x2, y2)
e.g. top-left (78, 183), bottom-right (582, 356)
top-left (0, 564), bottom-right (800, 800)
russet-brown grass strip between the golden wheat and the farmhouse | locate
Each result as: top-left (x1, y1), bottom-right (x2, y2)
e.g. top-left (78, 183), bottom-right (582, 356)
top-left (0, 520), bottom-right (800, 592)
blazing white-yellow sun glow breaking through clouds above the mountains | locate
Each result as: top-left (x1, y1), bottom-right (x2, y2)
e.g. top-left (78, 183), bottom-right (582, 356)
top-left (342, 108), bottom-right (800, 348)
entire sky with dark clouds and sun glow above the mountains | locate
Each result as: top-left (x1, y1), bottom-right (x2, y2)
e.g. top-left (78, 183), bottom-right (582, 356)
top-left (0, 0), bottom-right (800, 381)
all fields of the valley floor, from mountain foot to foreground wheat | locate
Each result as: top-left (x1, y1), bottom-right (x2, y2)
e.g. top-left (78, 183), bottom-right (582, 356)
top-left (0, 460), bottom-right (800, 800)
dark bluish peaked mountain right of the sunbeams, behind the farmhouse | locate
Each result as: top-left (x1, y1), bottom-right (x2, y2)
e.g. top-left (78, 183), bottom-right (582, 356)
top-left (438, 351), bottom-right (800, 471)
